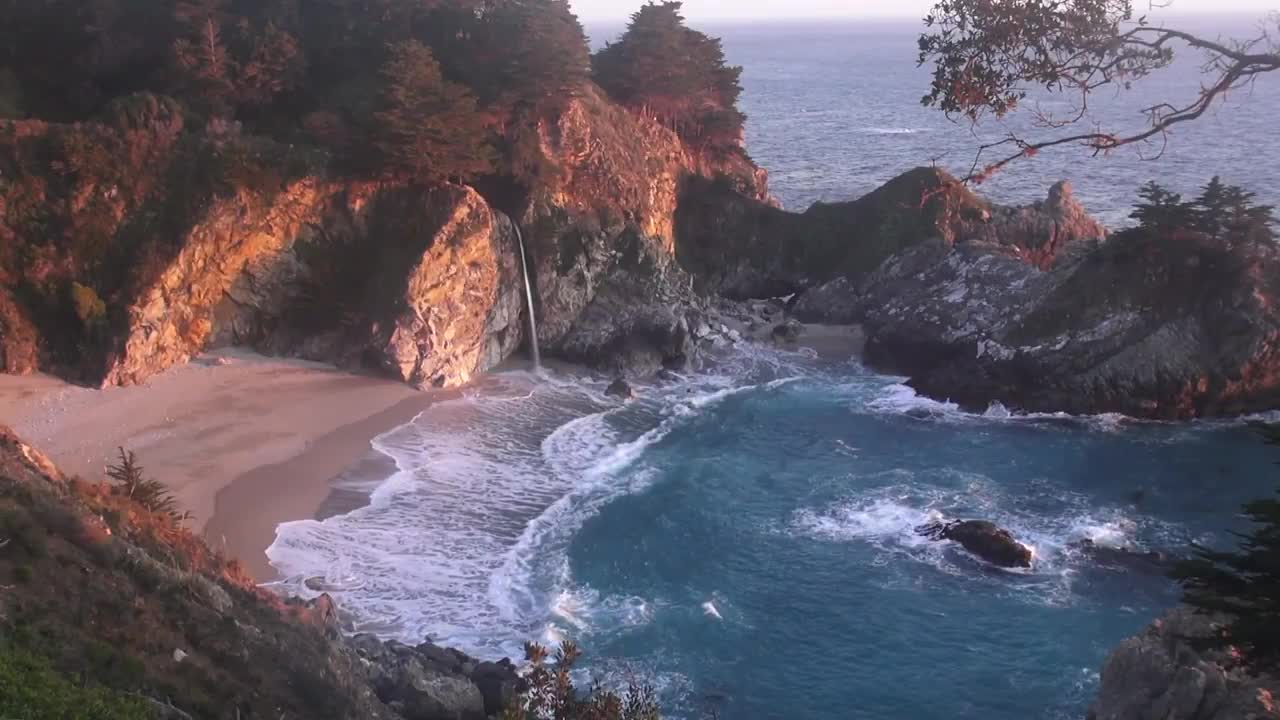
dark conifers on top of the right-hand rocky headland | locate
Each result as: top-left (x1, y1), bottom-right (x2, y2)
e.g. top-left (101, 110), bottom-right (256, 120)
top-left (1129, 176), bottom-right (1274, 242)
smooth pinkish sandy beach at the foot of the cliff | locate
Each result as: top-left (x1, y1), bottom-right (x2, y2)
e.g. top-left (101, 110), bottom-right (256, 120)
top-left (0, 351), bottom-right (439, 580)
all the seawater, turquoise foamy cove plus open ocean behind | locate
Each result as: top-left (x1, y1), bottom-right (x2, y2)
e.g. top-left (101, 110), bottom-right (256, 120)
top-left (269, 20), bottom-right (1280, 720)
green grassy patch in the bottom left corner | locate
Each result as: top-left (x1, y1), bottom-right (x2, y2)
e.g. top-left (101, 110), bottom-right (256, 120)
top-left (0, 647), bottom-right (150, 720)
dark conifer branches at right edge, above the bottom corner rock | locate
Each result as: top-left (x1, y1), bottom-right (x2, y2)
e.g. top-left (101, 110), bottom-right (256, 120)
top-left (1174, 425), bottom-right (1280, 670)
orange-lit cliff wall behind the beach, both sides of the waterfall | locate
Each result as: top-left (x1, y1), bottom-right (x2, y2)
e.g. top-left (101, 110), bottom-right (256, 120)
top-left (0, 88), bottom-right (768, 386)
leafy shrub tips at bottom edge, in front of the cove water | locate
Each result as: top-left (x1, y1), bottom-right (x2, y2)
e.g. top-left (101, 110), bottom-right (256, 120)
top-left (502, 641), bottom-right (660, 720)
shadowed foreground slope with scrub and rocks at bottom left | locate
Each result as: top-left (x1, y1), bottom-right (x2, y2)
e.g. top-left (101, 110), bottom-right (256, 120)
top-left (0, 427), bottom-right (520, 720)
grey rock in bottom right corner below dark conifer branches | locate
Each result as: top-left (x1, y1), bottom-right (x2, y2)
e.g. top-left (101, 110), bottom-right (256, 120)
top-left (1088, 609), bottom-right (1280, 720)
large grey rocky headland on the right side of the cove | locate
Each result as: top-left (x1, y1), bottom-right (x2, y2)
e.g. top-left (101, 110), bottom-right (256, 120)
top-left (860, 231), bottom-right (1280, 418)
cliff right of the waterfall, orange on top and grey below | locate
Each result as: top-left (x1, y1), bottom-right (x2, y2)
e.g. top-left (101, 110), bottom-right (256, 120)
top-left (517, 88), bottom-right (769, 375)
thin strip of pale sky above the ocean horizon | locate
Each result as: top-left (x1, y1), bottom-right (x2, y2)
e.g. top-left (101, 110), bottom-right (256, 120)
top-left (570, 0), bottom-right (1280, 22)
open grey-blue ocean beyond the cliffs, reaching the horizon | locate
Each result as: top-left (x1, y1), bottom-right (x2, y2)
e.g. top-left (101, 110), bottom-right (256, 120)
top-left (711, 15), bottom-right (1280, 225)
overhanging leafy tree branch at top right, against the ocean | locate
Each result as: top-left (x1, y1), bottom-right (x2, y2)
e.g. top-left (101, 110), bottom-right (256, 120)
top-left (919, 0), bottom-right (1280, 182)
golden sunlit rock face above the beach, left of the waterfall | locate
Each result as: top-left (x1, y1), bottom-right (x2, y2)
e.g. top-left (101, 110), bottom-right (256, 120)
top-left (104, 182), bottom-right (521, 387)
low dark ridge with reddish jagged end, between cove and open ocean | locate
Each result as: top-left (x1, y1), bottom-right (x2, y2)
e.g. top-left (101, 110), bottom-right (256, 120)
top-left (677, 168), bottom-right (1106, 298)
